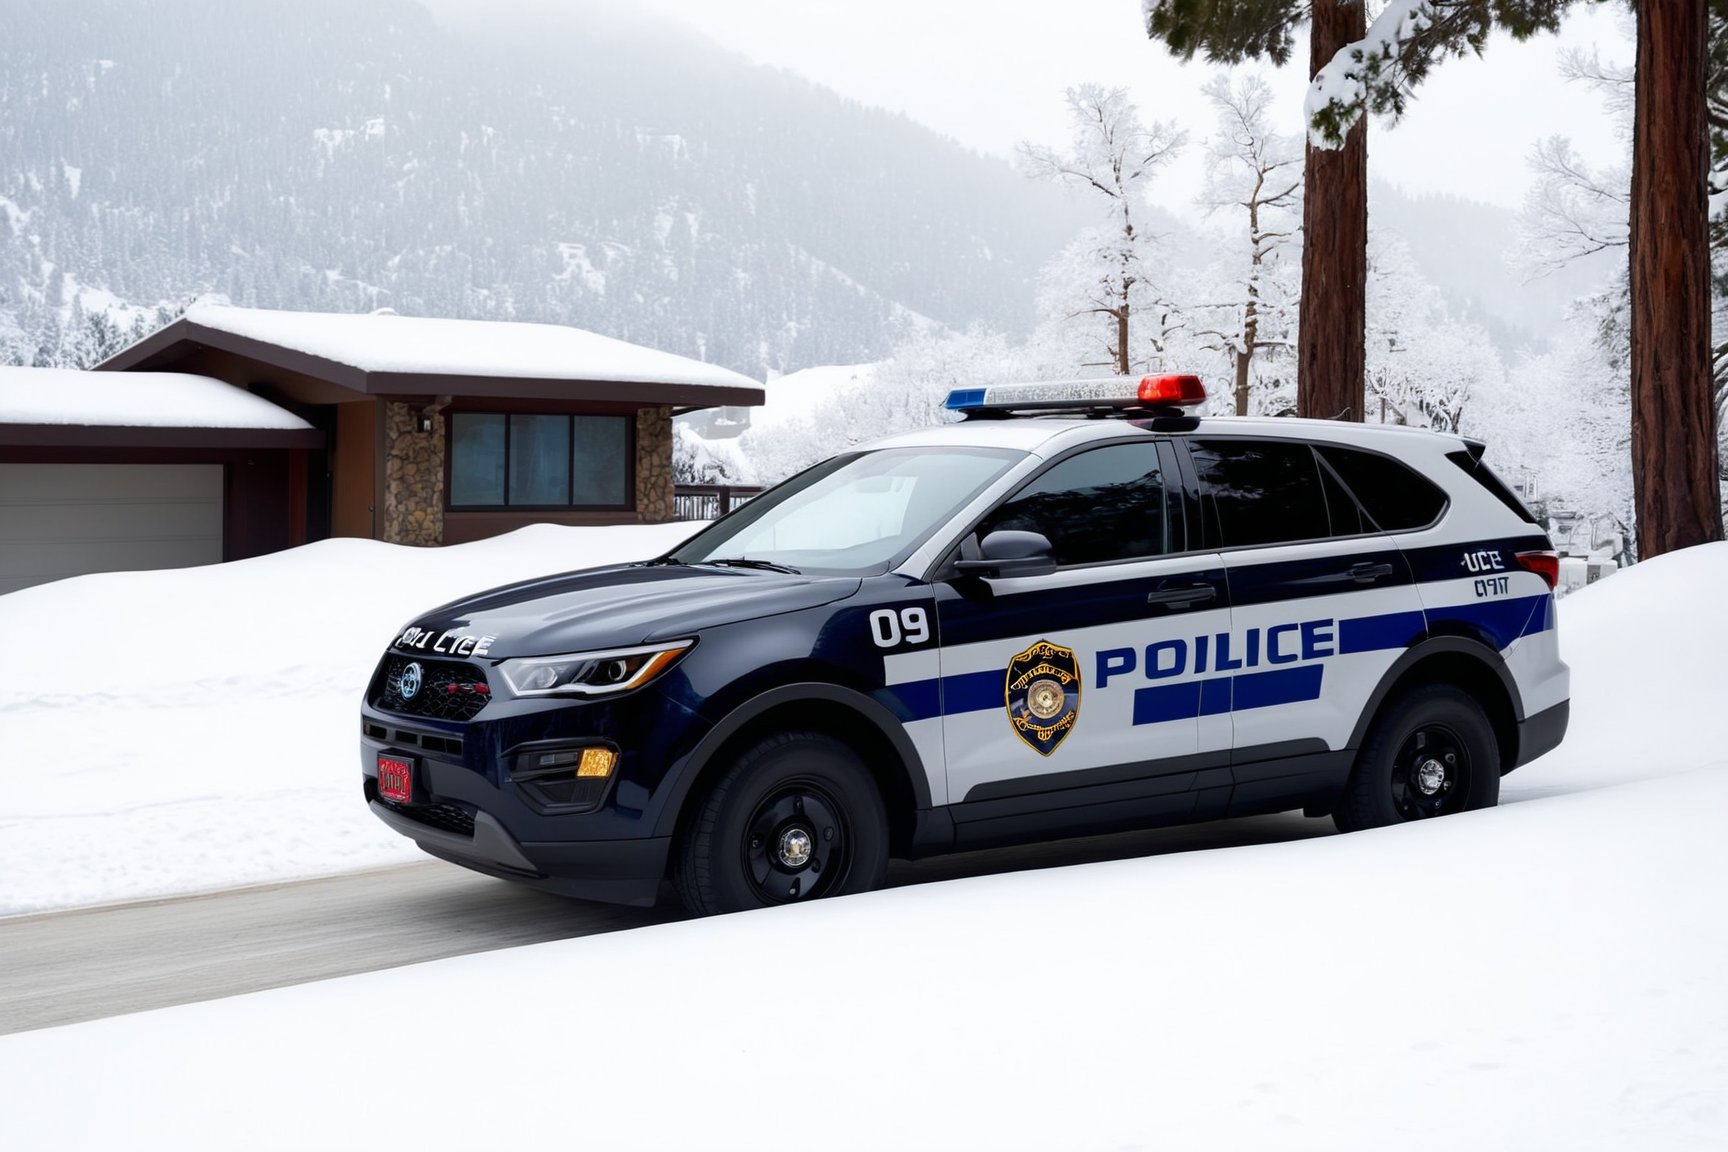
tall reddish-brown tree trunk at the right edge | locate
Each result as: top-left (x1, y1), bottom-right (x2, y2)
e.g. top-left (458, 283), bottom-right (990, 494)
top-left (1631, 0), bottom-right (1723, 558)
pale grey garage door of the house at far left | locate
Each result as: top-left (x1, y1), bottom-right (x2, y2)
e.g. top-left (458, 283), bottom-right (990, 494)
top-left (0, 465), bottom-right (223, 594)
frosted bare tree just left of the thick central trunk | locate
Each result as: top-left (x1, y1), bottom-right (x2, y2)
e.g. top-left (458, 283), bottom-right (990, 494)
top-left (1201, 74), bottom-right (1303, 416)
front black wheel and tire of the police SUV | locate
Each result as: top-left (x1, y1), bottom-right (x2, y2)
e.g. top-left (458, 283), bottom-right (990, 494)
top-left (672, 732), bottom-right (888, 915)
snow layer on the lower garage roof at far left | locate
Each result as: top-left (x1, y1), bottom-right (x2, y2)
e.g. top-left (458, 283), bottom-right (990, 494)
top-left (0, 368), bottom-right (311, 432)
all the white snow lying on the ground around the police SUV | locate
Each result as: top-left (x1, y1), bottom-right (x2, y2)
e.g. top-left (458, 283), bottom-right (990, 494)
top-left (0, 549), bottom-right (1728, 1152)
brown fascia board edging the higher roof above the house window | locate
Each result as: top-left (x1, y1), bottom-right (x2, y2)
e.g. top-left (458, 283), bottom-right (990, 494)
top-left (97, 320), bottom-right (767, 411)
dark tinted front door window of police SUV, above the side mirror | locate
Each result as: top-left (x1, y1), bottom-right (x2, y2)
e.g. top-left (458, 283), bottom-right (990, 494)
top-left (978, 440), bottom-right (1172, 565)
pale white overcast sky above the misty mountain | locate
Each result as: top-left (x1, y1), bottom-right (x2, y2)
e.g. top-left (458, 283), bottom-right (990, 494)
top-left (427, 0), bottom-right (1631, 209)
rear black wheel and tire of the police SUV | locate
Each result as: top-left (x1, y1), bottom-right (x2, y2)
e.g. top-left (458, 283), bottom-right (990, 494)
top-left (1332, 684), bottom-right (1500, 832)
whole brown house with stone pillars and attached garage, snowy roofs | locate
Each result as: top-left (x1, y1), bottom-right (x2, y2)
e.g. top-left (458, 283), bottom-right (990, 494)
top-left (0, 302), bottom-right (762, 591)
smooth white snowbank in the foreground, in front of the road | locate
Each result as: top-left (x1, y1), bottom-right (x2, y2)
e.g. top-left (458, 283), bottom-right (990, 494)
top-left (0, 765), bottom-right (1728, 1152)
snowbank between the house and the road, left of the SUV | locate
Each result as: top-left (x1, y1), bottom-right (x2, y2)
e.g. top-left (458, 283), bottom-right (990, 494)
top-left (0, 523), bottom-right (700, 915)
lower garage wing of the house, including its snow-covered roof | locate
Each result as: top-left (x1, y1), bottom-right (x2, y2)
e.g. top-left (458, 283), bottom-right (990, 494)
top-left (0, 368), bottom-right (325, 594)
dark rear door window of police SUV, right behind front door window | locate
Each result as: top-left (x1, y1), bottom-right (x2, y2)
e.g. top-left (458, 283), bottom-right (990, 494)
top-left (1189, 440), bottom-right (1332, 548)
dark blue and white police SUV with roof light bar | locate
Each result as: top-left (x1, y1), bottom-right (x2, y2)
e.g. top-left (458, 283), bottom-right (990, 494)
top-left (361, 377), bottom-right (1567, 912)
